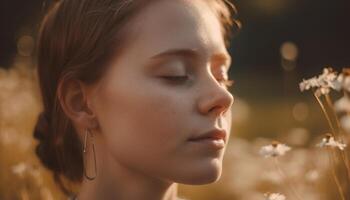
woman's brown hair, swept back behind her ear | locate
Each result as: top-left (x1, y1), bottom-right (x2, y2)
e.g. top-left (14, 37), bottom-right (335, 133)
top-left (34, 0), bottom-right (239, 195)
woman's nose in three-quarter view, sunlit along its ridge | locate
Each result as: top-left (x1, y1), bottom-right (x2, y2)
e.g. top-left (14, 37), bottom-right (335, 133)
top-left (198, 74), bottom-right (234, 117)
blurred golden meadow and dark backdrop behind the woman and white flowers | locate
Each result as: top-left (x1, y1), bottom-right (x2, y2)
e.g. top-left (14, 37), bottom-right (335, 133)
top-left (0, 0), bottom-right (350, 200)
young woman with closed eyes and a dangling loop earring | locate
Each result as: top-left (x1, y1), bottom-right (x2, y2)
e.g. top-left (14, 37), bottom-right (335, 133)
top-left (34, 0), bottom-right (239, 200)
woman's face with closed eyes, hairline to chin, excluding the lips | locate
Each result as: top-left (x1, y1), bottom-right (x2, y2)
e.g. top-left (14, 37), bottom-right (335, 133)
top-left (94, 0), bottom-right (233, 184)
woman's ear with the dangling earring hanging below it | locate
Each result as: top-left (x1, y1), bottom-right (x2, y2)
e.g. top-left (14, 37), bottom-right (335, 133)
top-left (58, 80), bottom-right (97, 131)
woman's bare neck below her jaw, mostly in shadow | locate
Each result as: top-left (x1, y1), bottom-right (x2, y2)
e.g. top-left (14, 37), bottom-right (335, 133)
top-left (77, 140), bottom-right (178, 200)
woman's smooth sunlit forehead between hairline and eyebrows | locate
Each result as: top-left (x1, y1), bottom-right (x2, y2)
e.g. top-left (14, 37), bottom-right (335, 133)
top-left (126, 0), bottom-right (226, 56)
